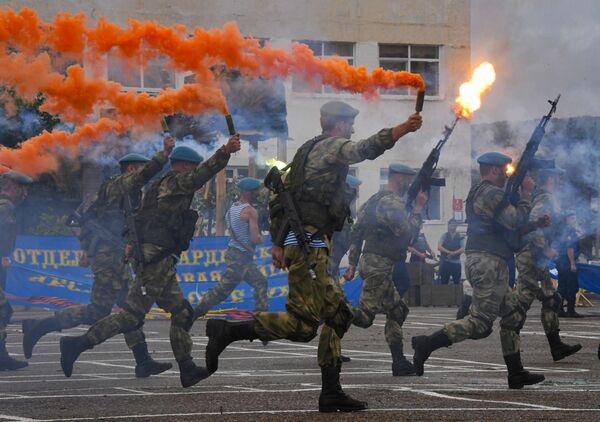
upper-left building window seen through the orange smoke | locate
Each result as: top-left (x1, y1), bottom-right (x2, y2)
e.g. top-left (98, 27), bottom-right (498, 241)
top-left (107, 50), bottom-right (175, 92)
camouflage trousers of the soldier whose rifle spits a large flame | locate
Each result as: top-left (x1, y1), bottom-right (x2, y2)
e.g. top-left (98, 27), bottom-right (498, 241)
top-left (353, 253), bottom-right (409, 345)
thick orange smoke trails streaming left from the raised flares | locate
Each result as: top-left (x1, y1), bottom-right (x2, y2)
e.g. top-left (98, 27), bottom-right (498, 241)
top-left (0, 8), bottom-right (424, 175)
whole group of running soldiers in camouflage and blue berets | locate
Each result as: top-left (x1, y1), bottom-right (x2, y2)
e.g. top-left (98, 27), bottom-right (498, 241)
top-left (0, 101), bottom-right (596, 412)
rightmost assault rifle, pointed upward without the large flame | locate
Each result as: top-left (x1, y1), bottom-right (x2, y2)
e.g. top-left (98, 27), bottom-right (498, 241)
top-left (499, 94), bottom-right (560, 210)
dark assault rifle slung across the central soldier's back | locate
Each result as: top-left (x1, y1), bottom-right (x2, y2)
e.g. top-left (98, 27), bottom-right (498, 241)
top-left (265, 166), bottom-right (317, 280)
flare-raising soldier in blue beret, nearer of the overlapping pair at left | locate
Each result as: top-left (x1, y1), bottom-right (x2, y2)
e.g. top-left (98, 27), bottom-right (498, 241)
top-left (60, 135), bottom-right (240, 387)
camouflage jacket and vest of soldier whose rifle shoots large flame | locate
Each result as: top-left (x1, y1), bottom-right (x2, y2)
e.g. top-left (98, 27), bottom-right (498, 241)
top-left (349, 192), bottom-right (422, 266)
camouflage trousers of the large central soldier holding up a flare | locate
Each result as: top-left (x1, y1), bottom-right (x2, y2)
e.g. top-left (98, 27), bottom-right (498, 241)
top-left (254, 246), bottom-right (353, 367)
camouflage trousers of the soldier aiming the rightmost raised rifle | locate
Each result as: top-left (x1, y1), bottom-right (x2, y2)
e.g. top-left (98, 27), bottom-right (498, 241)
top-left (443, 252), bottom-right (516, 348)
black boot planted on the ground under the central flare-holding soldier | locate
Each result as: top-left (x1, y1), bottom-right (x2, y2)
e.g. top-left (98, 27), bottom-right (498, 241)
top-left (319, 366), bottom-right (368, 412)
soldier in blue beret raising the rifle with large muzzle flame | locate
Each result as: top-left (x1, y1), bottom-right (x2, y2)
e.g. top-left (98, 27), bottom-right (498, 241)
top-left (348, 164), bottom-right (427, 376)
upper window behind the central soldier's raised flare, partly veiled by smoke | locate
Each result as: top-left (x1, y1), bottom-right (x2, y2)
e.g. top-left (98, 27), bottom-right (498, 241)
top-left (379, 44), bottom-right (440, 95)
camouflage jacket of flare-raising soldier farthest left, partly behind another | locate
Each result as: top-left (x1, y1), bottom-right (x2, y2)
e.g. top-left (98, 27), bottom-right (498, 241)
top-left (80, 153), bottom-right (168, 256)
